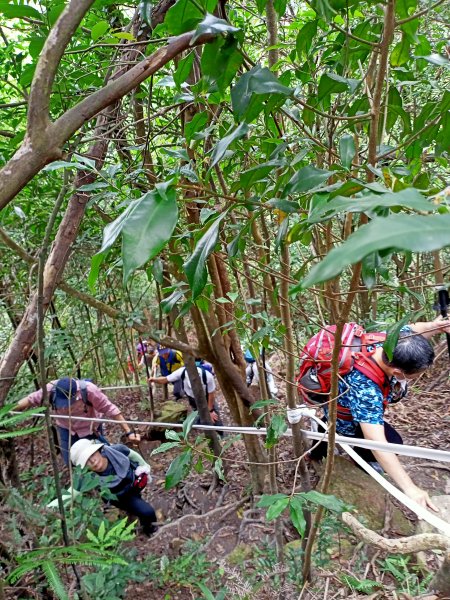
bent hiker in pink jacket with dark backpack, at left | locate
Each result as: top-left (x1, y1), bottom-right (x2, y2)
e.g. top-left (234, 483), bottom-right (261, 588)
top-left (15, 377), bottom-right (141, 465)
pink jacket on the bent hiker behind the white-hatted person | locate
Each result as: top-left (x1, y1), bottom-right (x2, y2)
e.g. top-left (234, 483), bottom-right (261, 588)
top-left (27, 380), bottom-right (120, 437)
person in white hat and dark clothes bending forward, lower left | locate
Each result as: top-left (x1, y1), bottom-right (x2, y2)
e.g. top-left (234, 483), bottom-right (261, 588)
top-left (48, 439), bottom-right (157, 535)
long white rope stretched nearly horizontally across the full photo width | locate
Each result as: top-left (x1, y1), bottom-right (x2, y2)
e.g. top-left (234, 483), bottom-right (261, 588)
top-left (11, 411), bottom-right (450, 462)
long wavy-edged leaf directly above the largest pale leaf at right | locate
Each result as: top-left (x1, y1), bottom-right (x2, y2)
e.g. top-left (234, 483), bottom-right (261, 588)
top-left (308, 188), bottom-right (437, 223)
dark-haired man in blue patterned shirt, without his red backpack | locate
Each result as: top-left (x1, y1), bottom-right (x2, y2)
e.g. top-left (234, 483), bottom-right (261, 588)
top-left (310, 317), bottom-right (450, 511)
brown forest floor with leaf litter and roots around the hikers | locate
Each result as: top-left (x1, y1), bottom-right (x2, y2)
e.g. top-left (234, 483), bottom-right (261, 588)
top-left (9, 347), bottom-right (450, 600)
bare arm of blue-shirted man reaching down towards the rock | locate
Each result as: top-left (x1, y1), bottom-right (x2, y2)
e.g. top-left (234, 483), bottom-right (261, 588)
top-left (360, 423), bottom-right (438, 511)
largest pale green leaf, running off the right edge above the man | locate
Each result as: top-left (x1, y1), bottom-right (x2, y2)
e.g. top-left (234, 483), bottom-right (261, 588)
top-left (291, 214), bottom-right (450, 293)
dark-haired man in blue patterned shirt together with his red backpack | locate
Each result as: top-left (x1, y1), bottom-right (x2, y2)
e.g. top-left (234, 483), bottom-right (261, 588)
top-left (297, 317), bottom-right (450, 511)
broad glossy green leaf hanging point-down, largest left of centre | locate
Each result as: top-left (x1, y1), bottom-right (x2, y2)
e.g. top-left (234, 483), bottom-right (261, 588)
top-left (122, 184), bottom-right (178, 284)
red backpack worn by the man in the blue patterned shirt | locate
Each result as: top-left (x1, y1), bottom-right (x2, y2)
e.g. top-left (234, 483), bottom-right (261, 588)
top-left (295, 323), bottom-right (390, 421)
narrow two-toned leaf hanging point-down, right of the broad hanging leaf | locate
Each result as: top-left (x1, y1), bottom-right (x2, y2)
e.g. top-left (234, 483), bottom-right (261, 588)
top-left (183, 211), bottom-right (227, 300)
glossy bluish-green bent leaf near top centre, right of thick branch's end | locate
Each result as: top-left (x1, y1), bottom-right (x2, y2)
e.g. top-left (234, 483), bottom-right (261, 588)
top-left (231, 65), bottom-right (293, 123)
